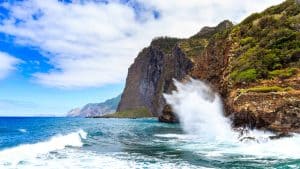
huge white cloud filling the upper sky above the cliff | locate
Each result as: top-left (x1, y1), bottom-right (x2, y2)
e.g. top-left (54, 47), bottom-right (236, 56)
top-left (0, 0), bottom-right (282, 88)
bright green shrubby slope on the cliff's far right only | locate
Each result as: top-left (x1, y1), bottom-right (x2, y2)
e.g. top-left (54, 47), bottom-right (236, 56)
top-left (230, 0), bottom-right (300, 84)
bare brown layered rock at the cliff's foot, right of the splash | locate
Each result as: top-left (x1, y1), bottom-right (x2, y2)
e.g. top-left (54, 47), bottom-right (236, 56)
top-left (229, 91), bottom-right (300, 132)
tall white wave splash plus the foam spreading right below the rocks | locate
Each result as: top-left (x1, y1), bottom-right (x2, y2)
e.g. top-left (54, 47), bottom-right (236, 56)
top-left (163, 79), bottom-right (300, 159)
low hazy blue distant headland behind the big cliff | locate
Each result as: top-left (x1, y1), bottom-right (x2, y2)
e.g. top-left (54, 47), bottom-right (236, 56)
top-left (67, 95), bottom-right (121, 117)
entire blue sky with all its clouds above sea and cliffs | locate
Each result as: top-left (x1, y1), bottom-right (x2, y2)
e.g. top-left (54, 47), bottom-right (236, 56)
top-left (0, 0), bottom-right (282, 116)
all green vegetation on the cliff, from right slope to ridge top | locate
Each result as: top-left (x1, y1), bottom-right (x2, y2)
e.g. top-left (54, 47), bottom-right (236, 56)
top-left (173, 0), bottom-right (300, 85)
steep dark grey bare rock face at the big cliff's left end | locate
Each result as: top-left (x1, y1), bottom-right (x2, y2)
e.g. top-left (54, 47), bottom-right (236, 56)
top-left (118, 38), bottom-right (193, 116)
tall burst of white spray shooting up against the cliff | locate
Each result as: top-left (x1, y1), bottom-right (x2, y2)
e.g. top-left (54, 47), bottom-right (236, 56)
top-left (164, 79), bottom-right (235, 141)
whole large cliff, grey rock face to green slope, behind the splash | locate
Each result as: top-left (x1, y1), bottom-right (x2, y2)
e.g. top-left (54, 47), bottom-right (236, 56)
top-left (118, 0), bottom-right (300, 132)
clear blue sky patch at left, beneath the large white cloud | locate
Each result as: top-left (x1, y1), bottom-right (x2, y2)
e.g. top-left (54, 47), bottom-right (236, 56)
top-left (0, 34), bottom-right (124, 116)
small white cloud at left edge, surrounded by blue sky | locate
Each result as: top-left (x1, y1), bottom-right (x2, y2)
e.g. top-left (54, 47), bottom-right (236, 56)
top-left (0, 51), bottom-right (20, 80)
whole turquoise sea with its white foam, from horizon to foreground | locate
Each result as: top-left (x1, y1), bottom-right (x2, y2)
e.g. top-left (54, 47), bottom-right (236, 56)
top-left (0, 118), bottom-right (300, 169)
